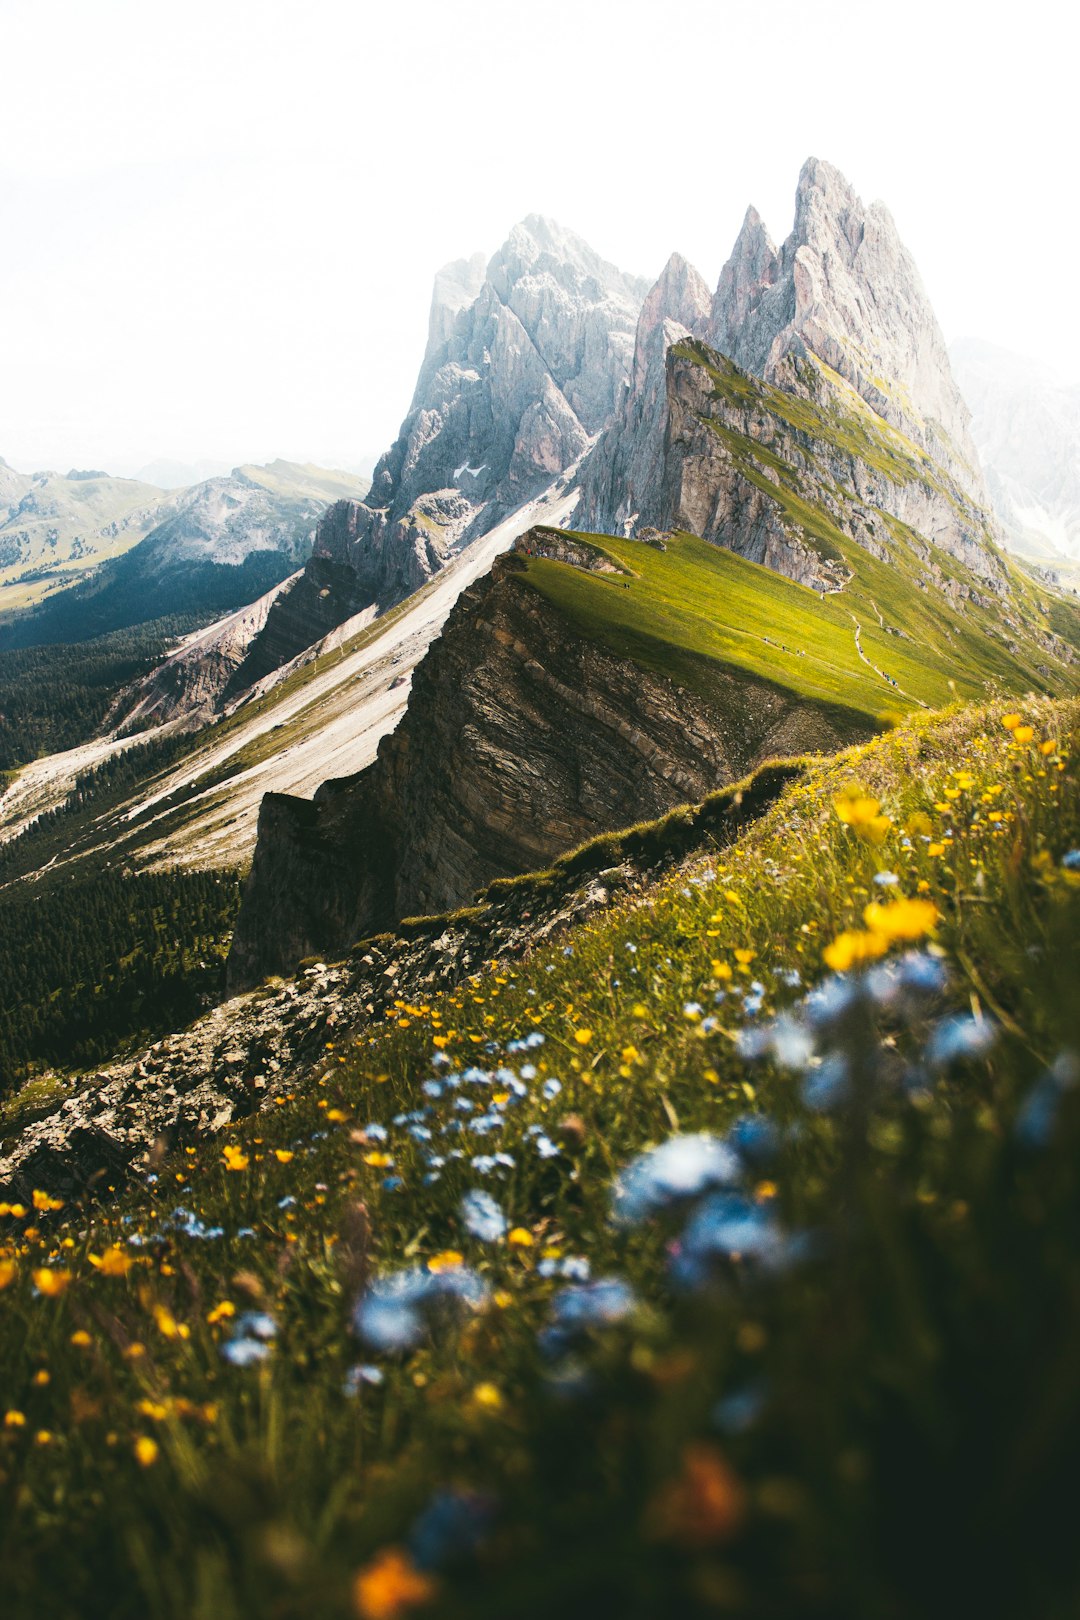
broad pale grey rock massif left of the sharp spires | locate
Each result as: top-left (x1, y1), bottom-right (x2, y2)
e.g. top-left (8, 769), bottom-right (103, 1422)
top-left (228, 214), bottom-right (648, 684)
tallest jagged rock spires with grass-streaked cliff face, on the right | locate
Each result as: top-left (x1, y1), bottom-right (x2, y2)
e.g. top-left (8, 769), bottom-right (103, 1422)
top-left (575, 159), bottom-right (1006, 593)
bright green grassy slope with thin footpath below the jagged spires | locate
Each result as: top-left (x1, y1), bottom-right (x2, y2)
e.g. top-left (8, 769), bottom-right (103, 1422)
top-left (523, 531), bottom-right (1080, 719)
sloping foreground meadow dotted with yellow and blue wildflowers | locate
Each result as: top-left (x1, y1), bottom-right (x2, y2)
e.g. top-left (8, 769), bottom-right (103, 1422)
top-left (0, 700), bottom-right (1080, 1620)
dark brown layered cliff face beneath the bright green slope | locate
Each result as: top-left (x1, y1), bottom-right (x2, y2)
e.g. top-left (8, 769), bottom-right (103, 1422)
top-left (230, 531), bottom-right (861, 987)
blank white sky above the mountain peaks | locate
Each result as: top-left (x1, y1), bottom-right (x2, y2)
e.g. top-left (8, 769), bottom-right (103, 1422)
top-left (0, 0), bottom-right (1080, 471)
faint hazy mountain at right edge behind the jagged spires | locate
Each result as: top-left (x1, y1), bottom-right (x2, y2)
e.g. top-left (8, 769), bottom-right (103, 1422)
top-left (950, 337), bottom-right (1080, 565)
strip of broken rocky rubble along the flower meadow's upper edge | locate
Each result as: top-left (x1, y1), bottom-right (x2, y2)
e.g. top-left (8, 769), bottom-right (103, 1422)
top-left (0, 763), bottom-right (801, 1202)
